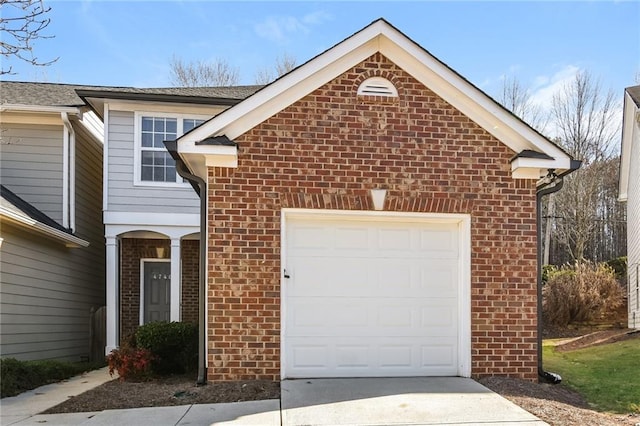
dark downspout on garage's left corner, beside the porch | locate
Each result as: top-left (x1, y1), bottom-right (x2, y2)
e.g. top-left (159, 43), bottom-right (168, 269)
top-left (164, 141), bottom-right (207, 386)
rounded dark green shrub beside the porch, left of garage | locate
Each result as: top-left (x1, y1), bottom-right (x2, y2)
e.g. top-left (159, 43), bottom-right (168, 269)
top-left (135, 322), bottom-right (198, 374)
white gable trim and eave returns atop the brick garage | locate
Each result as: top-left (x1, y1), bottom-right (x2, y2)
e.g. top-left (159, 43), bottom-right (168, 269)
top-left (178, 19), bottom-right (577, 183)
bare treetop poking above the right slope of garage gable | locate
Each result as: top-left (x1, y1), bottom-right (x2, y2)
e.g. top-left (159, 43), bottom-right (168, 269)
top-left (498, 77), bottom-right (549, 133)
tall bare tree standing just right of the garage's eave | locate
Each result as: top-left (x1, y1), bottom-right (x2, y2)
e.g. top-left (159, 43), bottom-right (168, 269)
top-left (551, 72), bottom-right (619, 261)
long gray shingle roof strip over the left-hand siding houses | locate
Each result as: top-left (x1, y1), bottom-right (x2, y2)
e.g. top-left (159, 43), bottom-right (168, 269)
top-left (0, 81), bottom-right (262, 107)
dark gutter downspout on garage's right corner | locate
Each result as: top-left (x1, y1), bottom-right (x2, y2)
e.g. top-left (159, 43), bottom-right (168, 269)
top-left (536, 160), bottom-right (582, 385)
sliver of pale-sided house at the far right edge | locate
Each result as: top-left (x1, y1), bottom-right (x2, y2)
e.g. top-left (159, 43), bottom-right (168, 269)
top-left (619, 86), bottom-right (640, 328)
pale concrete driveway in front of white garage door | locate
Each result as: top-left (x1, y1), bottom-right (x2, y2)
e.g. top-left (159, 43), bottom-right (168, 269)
top-left (280, 377), bottom-right (546, 426)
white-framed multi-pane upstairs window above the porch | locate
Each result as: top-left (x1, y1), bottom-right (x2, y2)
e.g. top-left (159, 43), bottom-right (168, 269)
top-left (134, 113), bottom-right (205, 186)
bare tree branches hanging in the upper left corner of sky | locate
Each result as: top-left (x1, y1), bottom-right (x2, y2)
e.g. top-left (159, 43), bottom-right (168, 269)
top-left (0, 0), bottom-right (58, 75)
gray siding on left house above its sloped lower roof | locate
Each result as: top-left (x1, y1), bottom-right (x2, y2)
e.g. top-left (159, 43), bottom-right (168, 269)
top-left (0, 124), bottom-right (63, 224)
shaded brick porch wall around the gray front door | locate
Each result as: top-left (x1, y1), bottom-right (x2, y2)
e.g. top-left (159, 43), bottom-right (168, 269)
top-left (120, 238), bottom-right (200, 340)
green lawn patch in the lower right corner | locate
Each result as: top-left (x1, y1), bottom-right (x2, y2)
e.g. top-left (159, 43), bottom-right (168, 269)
top-left (542, 338), bottom-right (640, 413)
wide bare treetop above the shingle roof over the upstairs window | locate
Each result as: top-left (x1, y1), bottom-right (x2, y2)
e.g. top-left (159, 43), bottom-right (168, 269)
top-left (170, 55), bottom-right (240, 87)
